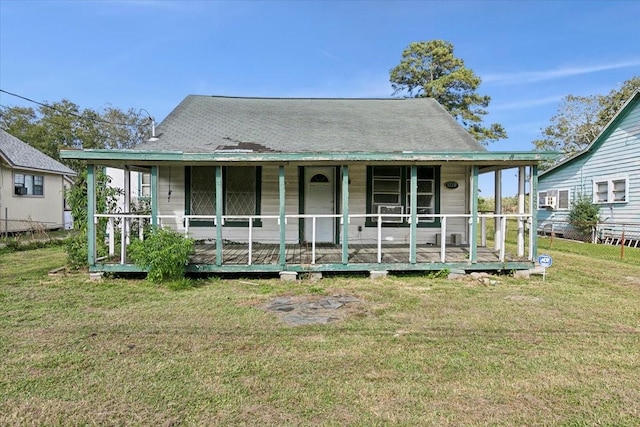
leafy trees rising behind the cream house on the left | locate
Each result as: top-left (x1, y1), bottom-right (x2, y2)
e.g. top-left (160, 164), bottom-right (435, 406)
top-left (0, 99), bottom-right (150, 171)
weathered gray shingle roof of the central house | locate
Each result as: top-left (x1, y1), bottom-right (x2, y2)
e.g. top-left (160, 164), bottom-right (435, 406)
top-left (136, 95), bottom-right (486, 153)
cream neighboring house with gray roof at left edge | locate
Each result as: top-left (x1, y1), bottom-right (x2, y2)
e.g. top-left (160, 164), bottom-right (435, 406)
top-left (0, 129), bottom-right (76, 233)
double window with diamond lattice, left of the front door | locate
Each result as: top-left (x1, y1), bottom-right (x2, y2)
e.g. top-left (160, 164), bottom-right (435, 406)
top-left (187, 166), bottom-right (262, 226)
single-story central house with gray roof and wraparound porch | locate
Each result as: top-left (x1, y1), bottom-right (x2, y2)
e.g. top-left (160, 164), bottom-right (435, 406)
top-left (61, 95), bottom-right (556, 274)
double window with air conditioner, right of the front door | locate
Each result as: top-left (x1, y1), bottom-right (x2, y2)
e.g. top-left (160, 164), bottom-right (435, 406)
top-left (366, 166), bottom-right (439, 226)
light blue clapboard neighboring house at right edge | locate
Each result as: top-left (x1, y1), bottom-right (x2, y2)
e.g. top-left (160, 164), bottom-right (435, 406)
top-left (538, 91), bottom-right (640, 246)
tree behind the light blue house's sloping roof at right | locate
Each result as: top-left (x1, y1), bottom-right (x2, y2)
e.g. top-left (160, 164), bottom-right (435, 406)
top-left (533, 76), bottom-right (640, 169)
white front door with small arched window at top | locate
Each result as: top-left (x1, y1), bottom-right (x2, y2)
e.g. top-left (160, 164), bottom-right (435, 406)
top-left (304, 167), bottom-right (336, 243)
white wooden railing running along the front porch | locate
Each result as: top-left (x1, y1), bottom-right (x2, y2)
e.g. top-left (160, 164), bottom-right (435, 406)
top-left (94, 213), bottom-right (536, 265)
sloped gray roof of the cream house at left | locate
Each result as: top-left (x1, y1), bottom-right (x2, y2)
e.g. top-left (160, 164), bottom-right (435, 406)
top-left (0, 129), bottom-right (76, 175)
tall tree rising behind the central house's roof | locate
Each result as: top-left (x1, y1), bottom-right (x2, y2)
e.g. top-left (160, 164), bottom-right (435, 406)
top-left (389, 40), bottom-right (507, 143)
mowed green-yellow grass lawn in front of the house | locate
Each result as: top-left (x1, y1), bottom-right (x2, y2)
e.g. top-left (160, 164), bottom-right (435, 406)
top-left (0, 239), bottom-right (640, 426)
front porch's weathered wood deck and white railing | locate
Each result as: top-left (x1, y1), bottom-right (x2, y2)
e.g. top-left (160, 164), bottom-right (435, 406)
top-left (96, 214), bottom-right (535, 274)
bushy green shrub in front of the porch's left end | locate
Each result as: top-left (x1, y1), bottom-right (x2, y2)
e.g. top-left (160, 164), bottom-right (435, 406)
top-left (129, 228), bottom-right (195, 283)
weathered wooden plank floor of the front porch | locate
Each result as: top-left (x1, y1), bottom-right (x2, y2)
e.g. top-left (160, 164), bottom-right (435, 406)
top-left (190, 243), bottom-right (527, 265)
